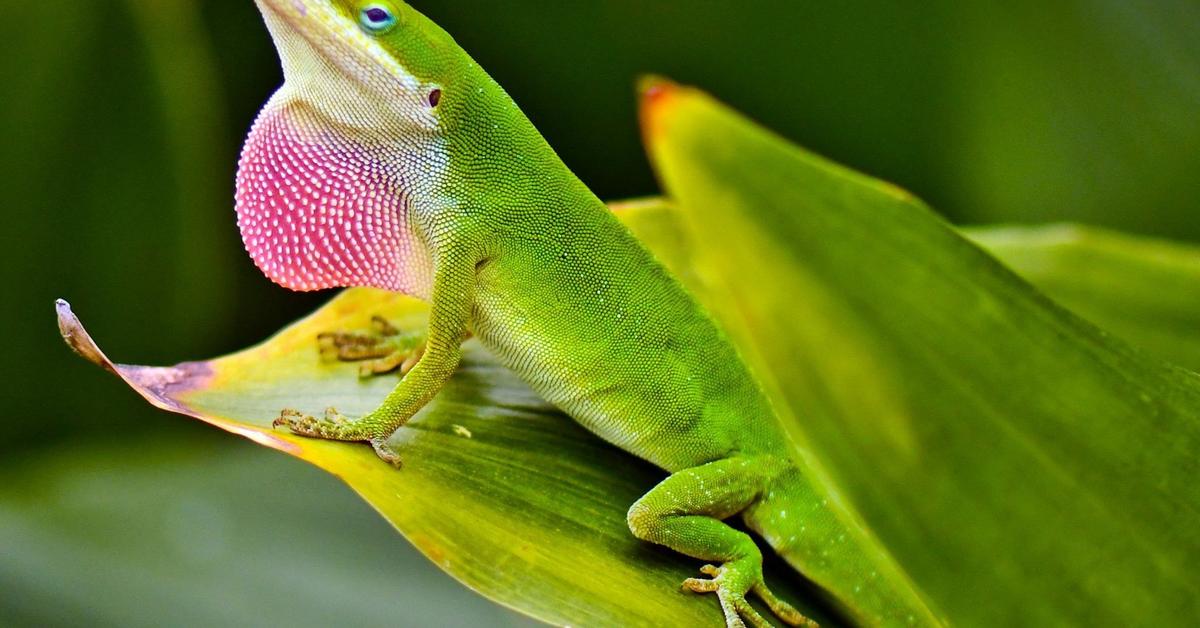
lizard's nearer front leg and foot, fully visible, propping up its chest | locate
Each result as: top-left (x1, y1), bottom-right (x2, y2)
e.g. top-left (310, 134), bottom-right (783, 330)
top-left (274, 255), bottom-right (478, 467)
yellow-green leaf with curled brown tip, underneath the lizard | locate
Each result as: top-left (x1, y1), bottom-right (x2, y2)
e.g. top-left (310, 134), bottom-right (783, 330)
top-left (59, 296), bottom-right (836, 626)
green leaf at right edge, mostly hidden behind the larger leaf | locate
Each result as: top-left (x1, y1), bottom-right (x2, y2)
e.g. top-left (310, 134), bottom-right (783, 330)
top-left (964, 225), bottom-right (1200, 371)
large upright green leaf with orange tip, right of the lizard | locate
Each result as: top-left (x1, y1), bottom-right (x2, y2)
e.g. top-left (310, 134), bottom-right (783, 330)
top-left (643, 83), bottom-right (1200, 626)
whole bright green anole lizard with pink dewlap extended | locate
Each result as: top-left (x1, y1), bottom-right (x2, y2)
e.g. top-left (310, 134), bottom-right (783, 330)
top-left (236, 0), bottom-right (940, 627)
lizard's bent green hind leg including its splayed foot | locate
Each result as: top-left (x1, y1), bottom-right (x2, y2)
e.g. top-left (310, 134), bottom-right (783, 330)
top-left (628, 456), bottom-right (816, 628)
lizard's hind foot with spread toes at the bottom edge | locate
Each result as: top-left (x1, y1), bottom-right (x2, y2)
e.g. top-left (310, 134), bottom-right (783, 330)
top-left (683, 562), bottom-right (817, 628)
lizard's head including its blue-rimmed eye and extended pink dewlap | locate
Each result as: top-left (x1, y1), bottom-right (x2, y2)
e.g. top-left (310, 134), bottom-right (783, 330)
top-left (236, 0), bottom-right (477, 297)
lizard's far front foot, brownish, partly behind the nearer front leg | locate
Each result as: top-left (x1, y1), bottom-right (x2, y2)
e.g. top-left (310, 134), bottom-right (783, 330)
top-left (317, 316), bottom-right (425, 378)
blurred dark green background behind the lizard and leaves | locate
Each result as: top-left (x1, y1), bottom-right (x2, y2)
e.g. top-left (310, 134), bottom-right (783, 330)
top-left (0, 0), bottom-right (1200, 626)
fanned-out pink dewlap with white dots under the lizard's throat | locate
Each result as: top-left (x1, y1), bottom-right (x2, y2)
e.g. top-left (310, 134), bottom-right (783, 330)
top-left (236, 106), bottom-right (428, 294)
